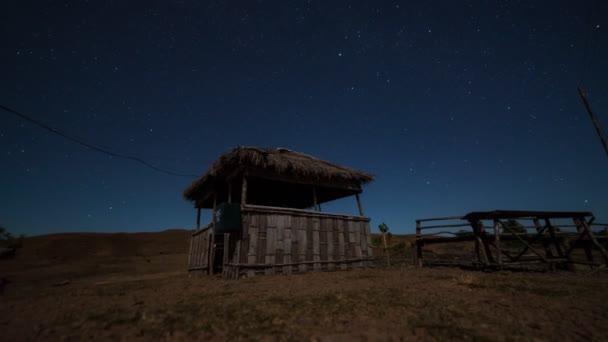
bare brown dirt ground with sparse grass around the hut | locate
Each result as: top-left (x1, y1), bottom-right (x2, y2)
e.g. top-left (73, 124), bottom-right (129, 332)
top-left (0, 230), bottom-right (608, 341)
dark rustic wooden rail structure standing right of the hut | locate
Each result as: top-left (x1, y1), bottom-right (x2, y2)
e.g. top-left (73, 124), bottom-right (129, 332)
top-left (414, 210), bottom-right (608, 269)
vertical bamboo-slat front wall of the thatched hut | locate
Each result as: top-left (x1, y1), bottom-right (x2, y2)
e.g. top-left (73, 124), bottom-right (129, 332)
top-left (224, 206), bottom-right (372, 277)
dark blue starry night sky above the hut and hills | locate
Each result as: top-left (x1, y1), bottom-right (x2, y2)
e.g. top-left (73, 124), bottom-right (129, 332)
top-left (0, 0), bottom-right (608, 235)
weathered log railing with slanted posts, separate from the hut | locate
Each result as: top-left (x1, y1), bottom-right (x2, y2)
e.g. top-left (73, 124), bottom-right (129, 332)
top-left (414, 216), bottom-right (608, 269)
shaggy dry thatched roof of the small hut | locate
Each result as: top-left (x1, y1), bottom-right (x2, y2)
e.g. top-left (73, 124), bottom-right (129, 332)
top-left (184, 147), bottom-right (374, 207)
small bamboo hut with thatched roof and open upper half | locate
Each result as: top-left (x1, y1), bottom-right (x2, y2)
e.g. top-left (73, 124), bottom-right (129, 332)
top-left (184, 147), bottom-right (373, 277)
